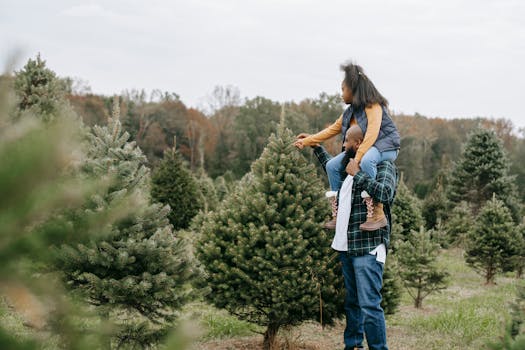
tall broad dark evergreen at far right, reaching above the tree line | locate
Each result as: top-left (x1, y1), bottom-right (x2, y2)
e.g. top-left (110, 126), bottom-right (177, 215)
top-left (448, 128), bottom-right (521, 221)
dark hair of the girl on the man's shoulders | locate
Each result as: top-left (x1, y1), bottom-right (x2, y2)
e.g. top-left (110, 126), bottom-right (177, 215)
top-left (341, 63), bottom-right (388, 108)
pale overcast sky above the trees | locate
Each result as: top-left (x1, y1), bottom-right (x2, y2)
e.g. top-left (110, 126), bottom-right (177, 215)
top-left (0, 0), bottom-right (525, 127)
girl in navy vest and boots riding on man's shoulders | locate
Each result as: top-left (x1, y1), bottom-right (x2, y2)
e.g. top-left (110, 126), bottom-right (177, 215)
top-left (295, 63), bottom-right (400, 231)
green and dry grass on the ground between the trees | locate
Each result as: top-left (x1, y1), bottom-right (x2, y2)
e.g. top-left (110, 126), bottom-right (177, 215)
top-left (0, 249), bottom-right (524, 350)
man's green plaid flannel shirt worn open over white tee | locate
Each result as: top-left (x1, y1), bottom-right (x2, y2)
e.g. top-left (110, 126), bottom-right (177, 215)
top-left (314, 146), bottom-right (399, 256)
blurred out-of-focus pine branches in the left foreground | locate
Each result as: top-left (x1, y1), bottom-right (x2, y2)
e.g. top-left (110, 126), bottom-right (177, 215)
top-left (0, 67), bottom-right (111, 350)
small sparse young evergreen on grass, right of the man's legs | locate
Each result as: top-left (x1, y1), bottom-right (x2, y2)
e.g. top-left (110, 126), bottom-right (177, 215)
top-left (396, 227), bottom-right (448, 308)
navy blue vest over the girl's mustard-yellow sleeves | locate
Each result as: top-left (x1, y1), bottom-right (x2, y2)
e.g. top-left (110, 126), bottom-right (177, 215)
top-left (341, 105), bottom-right (401, 152)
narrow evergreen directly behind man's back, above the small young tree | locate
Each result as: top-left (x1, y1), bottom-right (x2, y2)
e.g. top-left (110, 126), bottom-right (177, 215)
top-left (392, 178), bottom-right (423, 246)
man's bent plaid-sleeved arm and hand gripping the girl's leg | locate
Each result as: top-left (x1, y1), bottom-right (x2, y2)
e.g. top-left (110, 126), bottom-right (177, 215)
top-left (347, 159), bottom-right (397, 204)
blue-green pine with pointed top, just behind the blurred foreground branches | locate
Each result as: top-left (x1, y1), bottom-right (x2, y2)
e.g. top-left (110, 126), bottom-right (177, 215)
top-left (56, 95), bottom-right (192, 347)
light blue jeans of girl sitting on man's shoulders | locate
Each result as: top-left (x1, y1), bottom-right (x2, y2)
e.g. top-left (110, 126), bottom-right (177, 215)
top-left (326, 146), bottom-right (398, 191)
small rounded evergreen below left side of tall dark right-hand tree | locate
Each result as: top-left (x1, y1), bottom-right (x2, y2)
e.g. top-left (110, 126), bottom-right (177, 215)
top-left (444, 201), bottom-right (474, 248)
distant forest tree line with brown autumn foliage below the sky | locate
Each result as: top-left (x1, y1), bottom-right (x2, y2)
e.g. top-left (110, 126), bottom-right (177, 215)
top-left (65, 80), bottom-right (525, 198)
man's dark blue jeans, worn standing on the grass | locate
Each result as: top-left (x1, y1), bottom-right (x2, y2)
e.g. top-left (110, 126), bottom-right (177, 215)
top-left (339, 252), bottom-right (388, 350)
